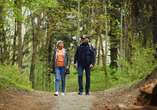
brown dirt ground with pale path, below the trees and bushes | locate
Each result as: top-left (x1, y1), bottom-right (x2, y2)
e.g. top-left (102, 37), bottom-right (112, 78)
top-left (0, 68), bottom-right (157, 110)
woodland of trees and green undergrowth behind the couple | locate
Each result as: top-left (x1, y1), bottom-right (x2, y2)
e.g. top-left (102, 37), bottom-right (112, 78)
top-left (0, 0), bottom-right (157, 91)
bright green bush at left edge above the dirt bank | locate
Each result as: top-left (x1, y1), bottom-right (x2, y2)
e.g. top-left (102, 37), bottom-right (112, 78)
top-left (0, 64), bottom-right (31, 90)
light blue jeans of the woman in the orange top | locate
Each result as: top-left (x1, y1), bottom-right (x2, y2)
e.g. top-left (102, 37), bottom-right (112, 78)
top-left (55, 66), bottom-right (66, 92)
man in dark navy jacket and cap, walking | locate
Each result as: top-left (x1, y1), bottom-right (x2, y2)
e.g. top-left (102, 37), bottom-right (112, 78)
top-left (74, 35), bottom-right (95, 95)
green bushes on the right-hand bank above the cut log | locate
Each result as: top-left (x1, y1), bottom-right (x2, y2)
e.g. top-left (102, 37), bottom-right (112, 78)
top-left (113, 44), bottom-right (157, 84)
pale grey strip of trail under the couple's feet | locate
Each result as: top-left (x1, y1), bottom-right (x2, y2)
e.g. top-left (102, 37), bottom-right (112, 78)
top-left (52, 92), bottom-right (96, 110)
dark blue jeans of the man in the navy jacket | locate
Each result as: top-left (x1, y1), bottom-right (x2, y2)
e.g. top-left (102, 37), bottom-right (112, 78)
top-left (78, 64), bottom-right (91, 93)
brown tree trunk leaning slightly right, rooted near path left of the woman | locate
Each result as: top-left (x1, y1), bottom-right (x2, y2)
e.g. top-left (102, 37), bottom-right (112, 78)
top-left (30, 11), bottom-right (40, 88)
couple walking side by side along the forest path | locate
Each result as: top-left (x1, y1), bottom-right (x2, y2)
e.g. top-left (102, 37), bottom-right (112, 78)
top-left (51, 35), bottom-right (95, 96)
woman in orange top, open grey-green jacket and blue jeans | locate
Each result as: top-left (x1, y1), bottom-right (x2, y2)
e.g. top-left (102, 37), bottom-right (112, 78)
top-left (51, 40), bottom-right (70, 96)
